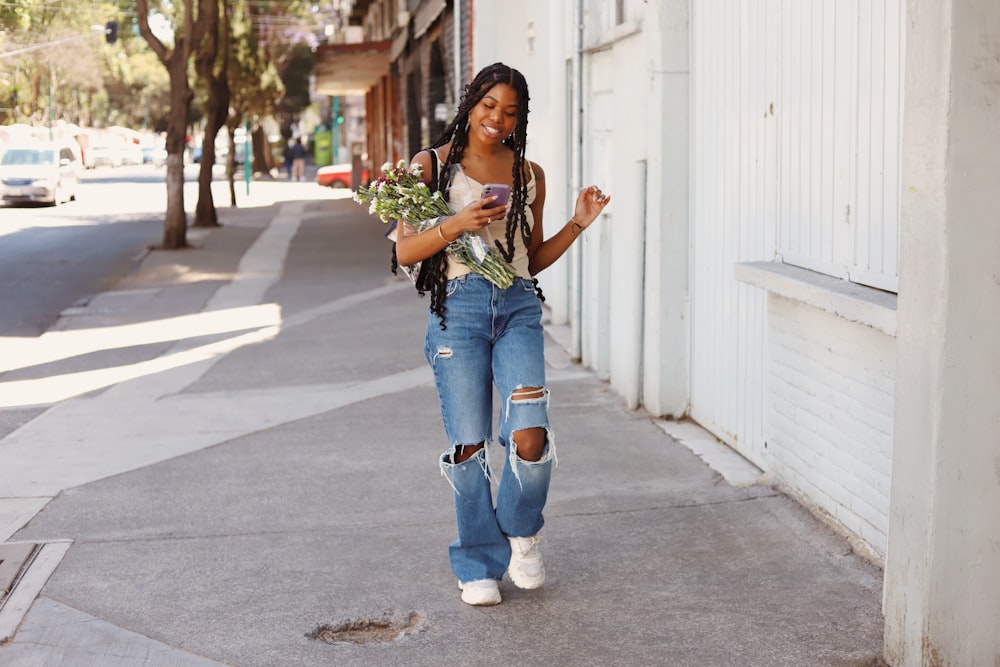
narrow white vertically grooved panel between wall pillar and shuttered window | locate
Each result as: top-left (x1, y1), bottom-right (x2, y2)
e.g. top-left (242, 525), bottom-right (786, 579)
top-left (690, 0), bottom-right (772, 463)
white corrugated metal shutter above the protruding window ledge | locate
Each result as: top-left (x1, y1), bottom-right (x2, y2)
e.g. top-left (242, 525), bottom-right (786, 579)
top-left (776, 0), bottom-right (904, 291)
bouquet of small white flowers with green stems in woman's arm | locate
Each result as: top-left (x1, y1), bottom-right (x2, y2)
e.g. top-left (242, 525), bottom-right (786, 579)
top-left (354, 160), bottom-right (517, 289)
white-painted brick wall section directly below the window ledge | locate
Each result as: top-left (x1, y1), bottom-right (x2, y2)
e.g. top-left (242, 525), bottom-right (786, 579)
top-left (765, 294), bottom-right (896, 558)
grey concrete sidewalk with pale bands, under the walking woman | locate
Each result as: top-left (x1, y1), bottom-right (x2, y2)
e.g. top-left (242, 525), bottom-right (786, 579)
top-left (0, 187), bottom-right (882, 667)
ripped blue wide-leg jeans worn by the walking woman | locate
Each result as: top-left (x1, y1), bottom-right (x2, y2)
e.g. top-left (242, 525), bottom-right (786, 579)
top-left (424, 273), bottom-right (555, 582)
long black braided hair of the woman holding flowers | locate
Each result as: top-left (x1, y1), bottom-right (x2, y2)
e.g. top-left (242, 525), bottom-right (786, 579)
top-left (393, 63), bottom-right (544, 329)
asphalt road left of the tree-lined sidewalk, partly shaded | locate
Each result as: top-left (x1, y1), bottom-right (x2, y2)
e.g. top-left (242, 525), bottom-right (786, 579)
top-left (0, 165), bottom-right (197, 337)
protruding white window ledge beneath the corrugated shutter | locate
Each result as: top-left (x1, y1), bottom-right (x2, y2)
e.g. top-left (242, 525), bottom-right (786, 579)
top-left (734, 262), bottom-right (896, 336)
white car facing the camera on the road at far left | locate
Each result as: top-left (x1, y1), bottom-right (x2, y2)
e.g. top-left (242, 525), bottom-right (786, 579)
top-left (0, 142), bottom-right (83, 205)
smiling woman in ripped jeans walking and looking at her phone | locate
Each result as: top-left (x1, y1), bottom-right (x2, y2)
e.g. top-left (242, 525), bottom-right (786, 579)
top-left (396, 63), bottom-right (610, 605)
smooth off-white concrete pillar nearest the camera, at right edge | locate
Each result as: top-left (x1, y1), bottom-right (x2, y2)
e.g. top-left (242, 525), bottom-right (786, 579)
top-left (885, 0), bottom-right (1000, 667)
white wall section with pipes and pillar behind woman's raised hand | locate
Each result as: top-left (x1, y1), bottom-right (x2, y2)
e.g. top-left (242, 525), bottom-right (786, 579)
top-left (474, 0), bottom-right (689, 416)
